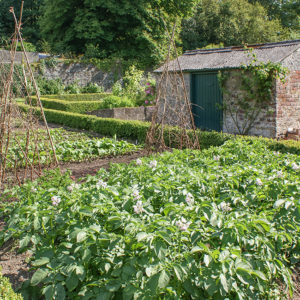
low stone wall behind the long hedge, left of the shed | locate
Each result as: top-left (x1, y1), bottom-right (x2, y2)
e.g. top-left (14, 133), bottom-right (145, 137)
top-left (88, 106), bottom-right (155, 122)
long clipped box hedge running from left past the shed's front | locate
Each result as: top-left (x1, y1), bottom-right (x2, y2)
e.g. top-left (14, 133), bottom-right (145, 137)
top-left (19, 104), bottom-right (300, 155)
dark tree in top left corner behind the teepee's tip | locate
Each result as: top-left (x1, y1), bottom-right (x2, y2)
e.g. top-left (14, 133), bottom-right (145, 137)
top-left (0, 0), bottom-right (43, 45)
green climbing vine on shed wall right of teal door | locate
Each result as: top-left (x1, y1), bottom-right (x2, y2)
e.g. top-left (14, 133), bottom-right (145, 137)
top-left (218, 49), bottom-right (288, 135)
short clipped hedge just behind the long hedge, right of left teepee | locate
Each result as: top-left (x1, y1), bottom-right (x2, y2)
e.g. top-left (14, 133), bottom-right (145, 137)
top-left (32, 97), bottom-right (103, 114)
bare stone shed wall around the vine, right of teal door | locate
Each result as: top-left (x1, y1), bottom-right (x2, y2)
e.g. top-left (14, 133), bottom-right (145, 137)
top-left (223, 70), bottom-right (276, 138)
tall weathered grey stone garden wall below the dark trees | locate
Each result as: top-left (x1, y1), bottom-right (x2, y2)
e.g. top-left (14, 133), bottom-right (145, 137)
top-left (43, 63), bottom-right (114, 91)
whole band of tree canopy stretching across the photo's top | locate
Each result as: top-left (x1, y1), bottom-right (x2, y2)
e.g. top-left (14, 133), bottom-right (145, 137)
top-left (0, 0), bottom-right (300, 66)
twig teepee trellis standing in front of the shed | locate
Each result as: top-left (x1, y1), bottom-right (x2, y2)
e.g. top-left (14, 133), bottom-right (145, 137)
top-left (146, 23), bottom-right (200, 151)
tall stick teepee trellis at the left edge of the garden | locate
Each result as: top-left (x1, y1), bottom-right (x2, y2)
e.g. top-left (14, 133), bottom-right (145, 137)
top-left (0, 1), bottom-right (58, 187)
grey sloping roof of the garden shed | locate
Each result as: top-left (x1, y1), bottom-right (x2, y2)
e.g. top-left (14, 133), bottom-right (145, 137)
top-left (155, 40), bottom-right (300, 72)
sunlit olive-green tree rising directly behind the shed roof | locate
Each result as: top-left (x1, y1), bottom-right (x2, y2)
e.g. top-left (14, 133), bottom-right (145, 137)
top-left (181, 0), bottom-right (288, 49)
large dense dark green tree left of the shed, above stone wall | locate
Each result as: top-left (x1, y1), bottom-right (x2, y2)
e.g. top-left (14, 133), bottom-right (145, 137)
top-left (40, 0), bottom-right (196, 65)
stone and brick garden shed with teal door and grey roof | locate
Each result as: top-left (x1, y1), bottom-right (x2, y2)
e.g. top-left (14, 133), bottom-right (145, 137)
top-left (155, 40), bottom-right (300, 138)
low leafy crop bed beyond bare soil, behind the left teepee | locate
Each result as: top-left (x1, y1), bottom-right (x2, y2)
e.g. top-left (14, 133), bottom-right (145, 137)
top-left (8, 128), bottom-right (139, 167)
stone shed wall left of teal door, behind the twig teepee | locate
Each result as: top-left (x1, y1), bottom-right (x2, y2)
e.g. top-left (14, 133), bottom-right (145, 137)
top-left (156, 72), bottom-right (191, 128)
